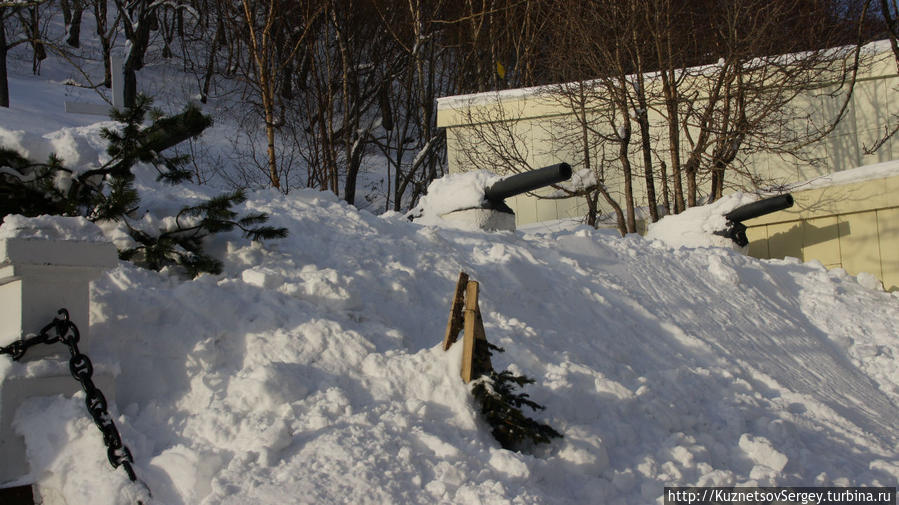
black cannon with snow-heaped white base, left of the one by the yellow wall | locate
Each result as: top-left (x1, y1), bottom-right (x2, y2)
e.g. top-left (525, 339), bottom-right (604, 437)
top-left (409, 163), bottom-right (571, 231)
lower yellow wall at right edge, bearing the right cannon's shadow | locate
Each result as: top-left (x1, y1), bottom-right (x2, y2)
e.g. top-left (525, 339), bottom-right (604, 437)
top-left (744, 176), bottom-right (899, 291)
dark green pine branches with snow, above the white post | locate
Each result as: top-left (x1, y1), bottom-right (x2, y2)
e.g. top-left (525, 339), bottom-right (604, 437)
top-left (0, 96), bottom-right (287, 277)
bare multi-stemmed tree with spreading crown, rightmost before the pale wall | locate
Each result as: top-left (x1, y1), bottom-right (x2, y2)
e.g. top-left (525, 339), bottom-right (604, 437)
top-left (679, 0), bottom-right (859, 201)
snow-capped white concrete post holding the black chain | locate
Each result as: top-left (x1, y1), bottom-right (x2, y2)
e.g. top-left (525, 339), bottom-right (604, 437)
top-left (0, 216), bottom-right (118, 487)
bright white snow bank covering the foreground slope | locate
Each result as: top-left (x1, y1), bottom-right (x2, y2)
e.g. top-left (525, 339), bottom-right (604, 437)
top-left (0, 50), bottom-right (899, 505)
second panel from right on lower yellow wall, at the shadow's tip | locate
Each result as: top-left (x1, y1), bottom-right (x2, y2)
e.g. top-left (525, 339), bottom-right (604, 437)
top-left (839, 211), bottom-right (883, 278)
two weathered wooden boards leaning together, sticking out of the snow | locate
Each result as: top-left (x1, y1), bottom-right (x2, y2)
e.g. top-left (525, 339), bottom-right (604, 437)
top-left (443, 272), bottom-right (493, 384)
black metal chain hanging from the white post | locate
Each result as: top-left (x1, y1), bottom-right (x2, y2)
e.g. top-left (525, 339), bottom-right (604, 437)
top-left (0, 309), bottom-right (149, 491)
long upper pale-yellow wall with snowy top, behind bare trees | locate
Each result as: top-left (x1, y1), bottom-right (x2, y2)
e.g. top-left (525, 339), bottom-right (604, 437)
top-left (437, 47), bottom-right (899, 225)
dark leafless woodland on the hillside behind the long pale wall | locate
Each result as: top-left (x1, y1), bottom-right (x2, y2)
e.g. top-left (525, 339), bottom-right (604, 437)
top-left (0, 0), bottom-right (895, 212)
